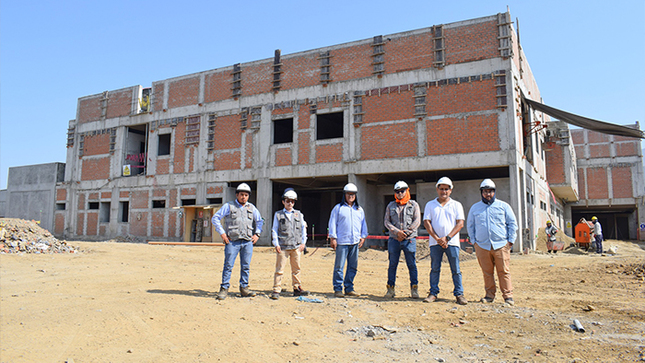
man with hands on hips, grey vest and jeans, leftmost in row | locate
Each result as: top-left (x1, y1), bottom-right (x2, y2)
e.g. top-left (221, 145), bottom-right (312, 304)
top-left (211, 183), bottom-right (264, 300)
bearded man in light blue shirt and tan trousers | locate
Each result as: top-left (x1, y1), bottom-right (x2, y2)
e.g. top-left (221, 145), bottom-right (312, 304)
top-left (466, 179), bottom-right (517, 305)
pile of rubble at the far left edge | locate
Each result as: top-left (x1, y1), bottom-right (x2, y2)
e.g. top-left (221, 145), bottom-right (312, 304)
top-left (0, 218), bottom-right (79, 253)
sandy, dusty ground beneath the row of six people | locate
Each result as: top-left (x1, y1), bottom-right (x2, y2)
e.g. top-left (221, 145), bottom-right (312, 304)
top-left (0, 241), bottom-right (645, 363)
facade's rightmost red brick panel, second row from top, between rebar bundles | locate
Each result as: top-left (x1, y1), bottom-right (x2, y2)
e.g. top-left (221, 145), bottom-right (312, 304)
top-left (426, 80), bottom-right (497, 116)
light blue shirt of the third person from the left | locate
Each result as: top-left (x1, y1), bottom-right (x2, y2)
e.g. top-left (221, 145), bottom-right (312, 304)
top-left (329, 203), bottom-right (367, 245)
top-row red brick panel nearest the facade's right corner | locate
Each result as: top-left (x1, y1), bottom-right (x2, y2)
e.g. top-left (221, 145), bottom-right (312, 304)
top-left (444, 21), bottom-right (499, 64)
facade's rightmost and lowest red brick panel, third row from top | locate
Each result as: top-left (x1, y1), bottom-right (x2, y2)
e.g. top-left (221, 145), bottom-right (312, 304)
top-left (426, 114), bottom-right (501, 155)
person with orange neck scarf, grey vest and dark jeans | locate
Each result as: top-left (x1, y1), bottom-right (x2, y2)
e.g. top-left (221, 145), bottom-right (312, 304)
top-left (383, 181), bottom-right (421, 299)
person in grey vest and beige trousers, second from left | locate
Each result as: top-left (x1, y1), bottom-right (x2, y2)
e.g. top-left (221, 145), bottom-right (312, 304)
top-left (271, 188), bottom-right (309, 300)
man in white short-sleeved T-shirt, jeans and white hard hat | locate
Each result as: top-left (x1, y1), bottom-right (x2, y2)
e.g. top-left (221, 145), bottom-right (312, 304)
top-left (423, 176), bottom-right (468, 305)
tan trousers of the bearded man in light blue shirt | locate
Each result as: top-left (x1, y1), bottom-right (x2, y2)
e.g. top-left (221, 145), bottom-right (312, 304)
top-left (475, 244), bottom-right (513, 299)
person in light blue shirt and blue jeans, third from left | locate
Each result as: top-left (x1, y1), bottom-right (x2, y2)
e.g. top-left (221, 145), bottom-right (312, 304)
top-left (328, 183), bottom-right (367, 297)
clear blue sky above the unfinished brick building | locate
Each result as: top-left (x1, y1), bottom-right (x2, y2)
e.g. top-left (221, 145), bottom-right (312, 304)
top-left (0, 0), bottom-right (645, 189)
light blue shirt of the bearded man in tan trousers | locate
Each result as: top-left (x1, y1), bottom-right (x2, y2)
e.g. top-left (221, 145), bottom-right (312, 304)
top-left (466, 199), bottom-right (517, 251)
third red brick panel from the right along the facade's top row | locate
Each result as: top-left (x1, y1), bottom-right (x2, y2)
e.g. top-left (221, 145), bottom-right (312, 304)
top-left (330, 44), bottom-right (372, 82)
